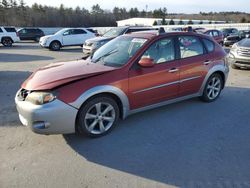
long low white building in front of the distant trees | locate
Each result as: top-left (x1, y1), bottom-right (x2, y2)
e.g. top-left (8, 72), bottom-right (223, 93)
top-left (116, 18), bottom-right (226, 26)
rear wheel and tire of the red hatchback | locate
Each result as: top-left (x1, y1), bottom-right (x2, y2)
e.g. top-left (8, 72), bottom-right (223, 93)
top-left (200, 73), bottom-right (224, 102)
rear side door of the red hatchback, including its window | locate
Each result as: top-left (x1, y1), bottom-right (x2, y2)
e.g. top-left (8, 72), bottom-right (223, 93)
top-left (178, 35), bottom-right (211, 96)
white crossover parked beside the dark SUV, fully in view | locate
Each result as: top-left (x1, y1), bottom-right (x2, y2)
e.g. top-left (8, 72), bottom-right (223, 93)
top-left (39, 28), bottom-right (96, 51)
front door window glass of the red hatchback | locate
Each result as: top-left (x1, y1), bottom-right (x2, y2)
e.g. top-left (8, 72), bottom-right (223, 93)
top-left (142, 38), bottom-right (175, 64)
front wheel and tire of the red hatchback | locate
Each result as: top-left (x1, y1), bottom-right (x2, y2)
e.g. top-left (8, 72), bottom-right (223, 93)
top-left (76, 95), bottom-right (119, 138)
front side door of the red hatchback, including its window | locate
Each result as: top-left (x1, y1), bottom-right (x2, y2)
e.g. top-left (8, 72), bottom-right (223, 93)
top-left (129, 38), bottom-right (179, 109)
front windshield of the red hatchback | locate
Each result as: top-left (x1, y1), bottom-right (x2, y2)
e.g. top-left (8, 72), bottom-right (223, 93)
top-left (91, 36), bottom-right (147, 67)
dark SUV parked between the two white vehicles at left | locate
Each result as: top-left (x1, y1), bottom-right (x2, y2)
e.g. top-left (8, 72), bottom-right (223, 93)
top-left (17, 28), bottom-right (44, 42)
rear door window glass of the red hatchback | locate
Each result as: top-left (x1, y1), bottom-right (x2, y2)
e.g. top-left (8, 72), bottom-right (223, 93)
top-left (178, 36), bottom-right (204, 58)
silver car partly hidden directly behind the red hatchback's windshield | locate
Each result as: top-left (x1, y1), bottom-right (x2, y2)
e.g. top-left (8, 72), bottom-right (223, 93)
top-left (82, 26), bottom-right (156, 58)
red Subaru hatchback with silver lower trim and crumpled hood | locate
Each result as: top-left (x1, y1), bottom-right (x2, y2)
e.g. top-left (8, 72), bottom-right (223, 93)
top-left (15, 31), bottom-right (229, 137)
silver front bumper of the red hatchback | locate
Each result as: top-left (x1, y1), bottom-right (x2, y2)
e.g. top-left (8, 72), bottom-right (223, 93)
top-left (15, 90), bottom-right (78, 135)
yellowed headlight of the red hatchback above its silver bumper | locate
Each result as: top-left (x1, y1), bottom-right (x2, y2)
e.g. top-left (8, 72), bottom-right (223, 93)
top-left (25, 91), bottom-right (56, 105)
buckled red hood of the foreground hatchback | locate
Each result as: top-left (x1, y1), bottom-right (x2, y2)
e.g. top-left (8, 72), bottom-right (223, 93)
top-left (22, 60), bottom-right (116, 90)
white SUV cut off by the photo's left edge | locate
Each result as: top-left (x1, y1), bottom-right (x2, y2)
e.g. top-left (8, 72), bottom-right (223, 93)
top-left (0, 27), bottom-right (20, 47)
